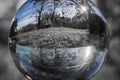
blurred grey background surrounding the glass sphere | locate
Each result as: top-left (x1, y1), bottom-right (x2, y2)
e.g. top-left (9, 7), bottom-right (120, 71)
top-left (0, 0), bottom-right (120, 80)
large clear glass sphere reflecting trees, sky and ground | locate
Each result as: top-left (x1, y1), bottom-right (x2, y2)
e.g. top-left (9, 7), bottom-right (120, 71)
top-left (9, 0), bottom-right (107, 80)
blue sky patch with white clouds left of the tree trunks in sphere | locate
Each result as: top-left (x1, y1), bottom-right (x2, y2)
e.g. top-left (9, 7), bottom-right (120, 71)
top-left (15, 2), bottom-right (38, 30)
